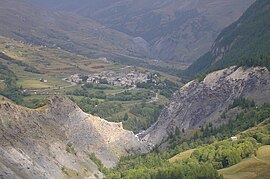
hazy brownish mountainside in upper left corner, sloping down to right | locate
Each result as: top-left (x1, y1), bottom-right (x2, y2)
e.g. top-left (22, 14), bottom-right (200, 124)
top-left (0, 0), bottom-right (150, 60)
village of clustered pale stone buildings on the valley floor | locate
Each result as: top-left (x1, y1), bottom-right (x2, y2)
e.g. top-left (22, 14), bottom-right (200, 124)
top-left (69, 71), bottom-right (151, 87)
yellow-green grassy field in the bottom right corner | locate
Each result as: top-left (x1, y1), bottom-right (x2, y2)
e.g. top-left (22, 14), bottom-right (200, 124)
top-left (219, 145), bottom-right (270, 179)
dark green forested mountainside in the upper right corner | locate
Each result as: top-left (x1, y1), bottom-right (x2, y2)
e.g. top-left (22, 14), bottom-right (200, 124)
top-left (183, 0), bottom-right (270, 77)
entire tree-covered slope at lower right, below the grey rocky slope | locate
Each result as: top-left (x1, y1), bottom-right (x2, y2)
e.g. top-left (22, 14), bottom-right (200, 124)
top-left (106, 99), bottom-right (270, 179)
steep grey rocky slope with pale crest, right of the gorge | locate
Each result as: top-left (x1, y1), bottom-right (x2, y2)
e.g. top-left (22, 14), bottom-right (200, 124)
top-left (140, 66), bottom-right (270, 146)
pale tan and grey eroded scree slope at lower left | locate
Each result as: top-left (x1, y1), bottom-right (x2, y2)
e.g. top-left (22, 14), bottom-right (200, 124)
top-left (0, 97), bottom-right (140, 178)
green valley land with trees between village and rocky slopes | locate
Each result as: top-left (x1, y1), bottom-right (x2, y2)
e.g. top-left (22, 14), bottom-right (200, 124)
top-left (62, 73), bottom-right (179, 133)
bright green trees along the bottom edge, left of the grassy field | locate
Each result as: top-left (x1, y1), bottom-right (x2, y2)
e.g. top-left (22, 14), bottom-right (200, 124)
top-left (106, 157), bottom-right (219, 179)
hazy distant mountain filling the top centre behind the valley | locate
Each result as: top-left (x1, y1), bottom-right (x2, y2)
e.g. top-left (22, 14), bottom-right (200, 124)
top-left (28, 0), bottom-right (255, 63)
